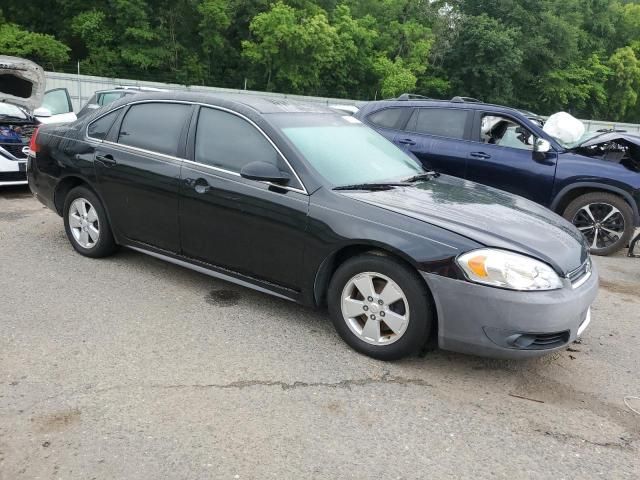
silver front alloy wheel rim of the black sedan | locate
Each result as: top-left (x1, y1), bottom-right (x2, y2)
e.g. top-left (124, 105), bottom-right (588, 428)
top-left (341, 272), bottom-right (409, 345)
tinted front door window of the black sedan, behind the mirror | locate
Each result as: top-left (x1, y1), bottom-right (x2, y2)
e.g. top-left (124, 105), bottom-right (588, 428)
top-left (195, 107), bottom-right (301, 188)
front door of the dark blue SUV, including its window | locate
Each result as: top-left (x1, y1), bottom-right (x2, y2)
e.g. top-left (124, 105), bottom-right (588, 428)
top-left (467, 111), bottom-right (558, 205)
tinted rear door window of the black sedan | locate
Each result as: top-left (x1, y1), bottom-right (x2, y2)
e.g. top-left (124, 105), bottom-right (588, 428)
top-left (118, 103), bottom-right (191, 157)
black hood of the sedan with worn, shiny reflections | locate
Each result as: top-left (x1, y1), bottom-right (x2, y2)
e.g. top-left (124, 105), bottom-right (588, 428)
top-left (340, 175), bottom-right (588, 275)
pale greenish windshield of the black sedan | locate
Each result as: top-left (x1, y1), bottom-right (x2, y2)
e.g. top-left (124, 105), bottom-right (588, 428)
top-left (273, 114), bottom-right (424, 186)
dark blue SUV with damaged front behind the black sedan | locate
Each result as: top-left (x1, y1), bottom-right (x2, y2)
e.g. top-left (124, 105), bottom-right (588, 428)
top-left (355, 97), bottom-right (640, 255)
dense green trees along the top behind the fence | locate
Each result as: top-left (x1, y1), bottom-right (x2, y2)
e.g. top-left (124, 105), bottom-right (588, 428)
top-left (0, 0), bottom-right (640, 122)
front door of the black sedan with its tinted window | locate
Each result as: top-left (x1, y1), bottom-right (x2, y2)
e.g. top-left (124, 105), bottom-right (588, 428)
top-left (180, 107), bottom-right (309, 290)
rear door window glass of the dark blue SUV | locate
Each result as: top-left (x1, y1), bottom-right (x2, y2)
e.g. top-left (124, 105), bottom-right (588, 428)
top-left (407, 108), bottom-right (469, 139)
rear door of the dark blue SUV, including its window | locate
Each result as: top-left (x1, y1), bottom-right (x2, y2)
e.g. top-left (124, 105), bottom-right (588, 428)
top-left (394, 107), bottom-right (473, 178)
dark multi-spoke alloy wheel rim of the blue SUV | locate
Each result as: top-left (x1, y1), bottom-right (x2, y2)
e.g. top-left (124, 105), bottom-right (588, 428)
top-left (572, 203), bottom-right (625, 250)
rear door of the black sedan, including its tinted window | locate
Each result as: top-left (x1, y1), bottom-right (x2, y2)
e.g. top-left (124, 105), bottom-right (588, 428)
top-left (88, 102), bottom-right (193, 253)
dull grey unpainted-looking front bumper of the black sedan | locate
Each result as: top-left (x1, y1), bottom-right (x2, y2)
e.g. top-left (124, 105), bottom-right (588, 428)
top-left (422, 265), bottom-right (598, 358)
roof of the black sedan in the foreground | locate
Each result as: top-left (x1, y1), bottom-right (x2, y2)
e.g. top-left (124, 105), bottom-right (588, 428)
top-left (99, 91), bottom-right (336, 115)
